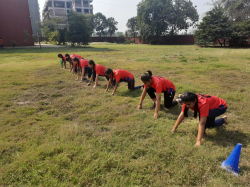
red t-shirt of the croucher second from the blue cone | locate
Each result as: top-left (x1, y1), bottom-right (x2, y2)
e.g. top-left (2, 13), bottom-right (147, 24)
top-left (144, 76), bottom-right (175, 93)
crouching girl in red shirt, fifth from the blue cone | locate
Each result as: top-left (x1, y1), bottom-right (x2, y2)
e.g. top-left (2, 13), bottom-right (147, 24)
top-left (73, 57), bottom-right (92, 82)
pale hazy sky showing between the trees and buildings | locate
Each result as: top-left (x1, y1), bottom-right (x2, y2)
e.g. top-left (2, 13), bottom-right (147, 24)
top-left (38, 0), bottom-right (211, 32)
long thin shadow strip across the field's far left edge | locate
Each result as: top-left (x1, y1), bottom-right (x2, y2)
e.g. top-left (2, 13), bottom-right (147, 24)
top-left (1, 46), bottom-right (119, 54)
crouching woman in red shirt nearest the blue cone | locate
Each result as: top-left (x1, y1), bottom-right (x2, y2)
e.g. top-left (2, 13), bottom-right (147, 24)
top-left (172, 92), bottom-right (227, 146)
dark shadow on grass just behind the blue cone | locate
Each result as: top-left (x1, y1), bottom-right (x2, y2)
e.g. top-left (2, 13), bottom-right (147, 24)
top-left (206, 126), bottom-right (250, 147)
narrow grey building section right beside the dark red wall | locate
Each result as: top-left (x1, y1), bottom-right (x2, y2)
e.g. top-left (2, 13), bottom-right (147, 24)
top-left (28, 0), bottom-right (41, 36)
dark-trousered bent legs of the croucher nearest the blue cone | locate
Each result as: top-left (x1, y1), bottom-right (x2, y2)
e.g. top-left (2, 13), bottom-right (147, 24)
top-left (206, 108), bottom-right (227, 128)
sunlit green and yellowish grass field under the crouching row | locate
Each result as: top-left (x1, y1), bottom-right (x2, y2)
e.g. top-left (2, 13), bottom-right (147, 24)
top-left (0, 45), bottom-right (250, 187)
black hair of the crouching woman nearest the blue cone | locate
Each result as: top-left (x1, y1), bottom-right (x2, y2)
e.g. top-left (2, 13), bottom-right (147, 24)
top-left (181, 92), bottom-right (198, 118)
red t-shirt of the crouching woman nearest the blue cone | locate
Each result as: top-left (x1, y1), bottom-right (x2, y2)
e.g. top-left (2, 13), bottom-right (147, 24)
top-left (182, 94), bottom-right (227, 117)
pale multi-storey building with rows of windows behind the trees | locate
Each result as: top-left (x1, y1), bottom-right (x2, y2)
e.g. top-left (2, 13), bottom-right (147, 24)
top-left (43, 0), bottom-right (93, 28)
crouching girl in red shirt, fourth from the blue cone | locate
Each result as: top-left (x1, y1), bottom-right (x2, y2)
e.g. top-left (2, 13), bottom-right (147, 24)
top-left (88, 60), bottom-right (108, 88)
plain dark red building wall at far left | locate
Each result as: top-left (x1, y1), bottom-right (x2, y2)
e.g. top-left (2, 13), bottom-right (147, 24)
top-left (0, 0), bottom-right (34, 47)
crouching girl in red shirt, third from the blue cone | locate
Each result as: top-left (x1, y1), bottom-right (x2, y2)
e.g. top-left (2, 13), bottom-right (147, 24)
top-left (105, 68), bottom-right (141, 95)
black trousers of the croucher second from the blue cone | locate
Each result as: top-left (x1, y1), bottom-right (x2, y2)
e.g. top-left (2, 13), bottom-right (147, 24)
top-left (147, 86), bottom-right (178, 108)
